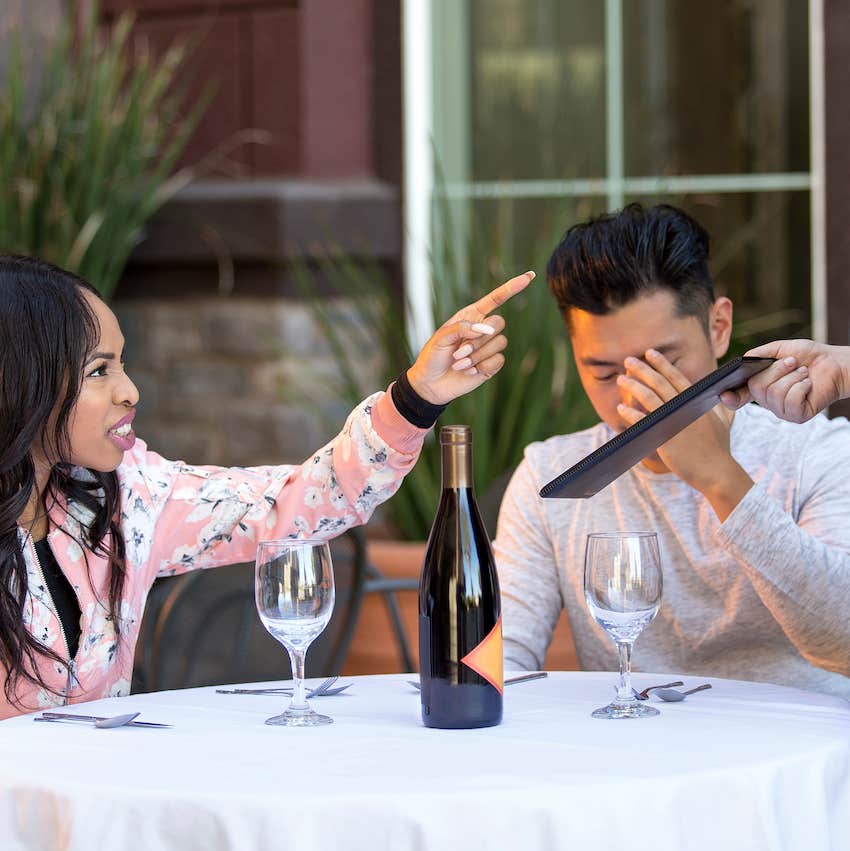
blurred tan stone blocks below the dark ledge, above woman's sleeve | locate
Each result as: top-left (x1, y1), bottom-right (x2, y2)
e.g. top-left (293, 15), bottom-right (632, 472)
top-left (112, 295), bottom-right (382, 466)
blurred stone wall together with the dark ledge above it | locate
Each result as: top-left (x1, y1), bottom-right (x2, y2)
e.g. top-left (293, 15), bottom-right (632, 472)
top-left (113, 179), bottom-right (404, 472)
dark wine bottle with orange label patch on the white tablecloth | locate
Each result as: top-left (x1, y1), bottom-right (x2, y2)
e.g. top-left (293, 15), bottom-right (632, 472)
top-left (419, 426), bottom-right (503, 728)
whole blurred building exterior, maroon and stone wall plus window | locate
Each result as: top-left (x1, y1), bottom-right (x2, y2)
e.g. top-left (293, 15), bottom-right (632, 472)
top-left (4, 0), bottom-right (850, 464)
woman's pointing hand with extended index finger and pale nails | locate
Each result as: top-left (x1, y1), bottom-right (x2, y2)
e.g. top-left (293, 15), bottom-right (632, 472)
top-left (407, 272), bottom-right (534, 405)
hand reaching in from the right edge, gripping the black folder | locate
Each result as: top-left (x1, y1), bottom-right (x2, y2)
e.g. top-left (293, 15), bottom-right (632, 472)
top-left (720, 340), bottom-right (850, 423)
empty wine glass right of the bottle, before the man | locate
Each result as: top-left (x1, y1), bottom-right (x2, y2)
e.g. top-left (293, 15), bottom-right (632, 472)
top-left (584, 532), bottom-right (662, 718)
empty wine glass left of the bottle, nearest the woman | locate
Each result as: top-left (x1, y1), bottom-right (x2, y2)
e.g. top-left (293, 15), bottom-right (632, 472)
top-left (254, 539), bottom-right (334, 727)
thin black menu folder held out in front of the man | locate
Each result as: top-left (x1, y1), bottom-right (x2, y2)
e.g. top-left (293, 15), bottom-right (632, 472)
top-left (540, 357), bottom-right (773, 499)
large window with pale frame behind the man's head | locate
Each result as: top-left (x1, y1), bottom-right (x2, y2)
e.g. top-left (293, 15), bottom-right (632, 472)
top-left (414, 0), bottom-right (812, 348)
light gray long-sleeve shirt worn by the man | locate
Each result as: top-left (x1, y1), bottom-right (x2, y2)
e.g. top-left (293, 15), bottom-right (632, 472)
top-left (494, 405), bottom-right (850, 699)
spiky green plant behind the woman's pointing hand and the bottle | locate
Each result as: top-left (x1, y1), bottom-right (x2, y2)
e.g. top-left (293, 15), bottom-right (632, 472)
top-left (297, 201), bottom-right (597, 540)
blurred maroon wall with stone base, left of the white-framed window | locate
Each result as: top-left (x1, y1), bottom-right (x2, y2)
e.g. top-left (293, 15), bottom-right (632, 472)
top-left (101, 0), bottom-right (401, 465)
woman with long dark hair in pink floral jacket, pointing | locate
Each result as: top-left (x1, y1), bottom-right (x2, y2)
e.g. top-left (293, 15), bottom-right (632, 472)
top-left (0, 256), bottom-right (534, 718)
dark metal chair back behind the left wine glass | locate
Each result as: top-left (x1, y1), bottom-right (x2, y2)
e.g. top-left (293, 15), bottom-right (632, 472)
top-left (133, 529), bottom-right (368, 692)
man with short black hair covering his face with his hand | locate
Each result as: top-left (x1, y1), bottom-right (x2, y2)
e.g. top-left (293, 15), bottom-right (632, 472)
top-left (495, 205), bottom-right (850, 697)
